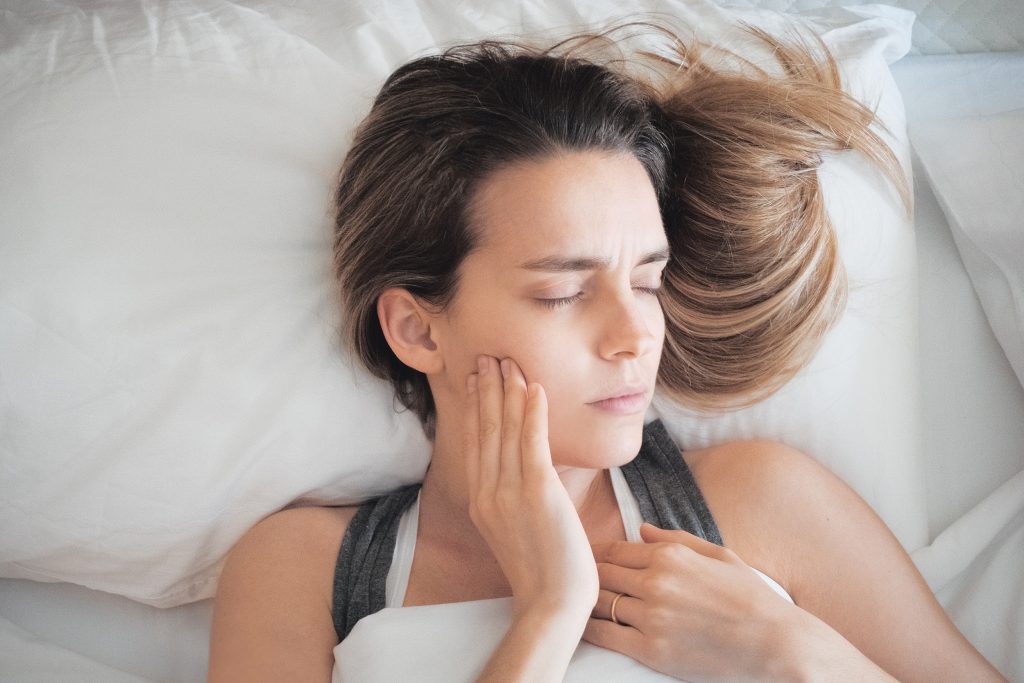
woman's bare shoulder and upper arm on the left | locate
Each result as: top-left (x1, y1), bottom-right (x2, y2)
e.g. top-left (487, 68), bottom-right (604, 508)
top-left (209, 507), bottom-right (358, 681)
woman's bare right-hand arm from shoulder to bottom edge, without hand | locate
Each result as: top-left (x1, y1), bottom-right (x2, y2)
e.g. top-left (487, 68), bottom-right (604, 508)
top-left (693, 441), bottom-right (1005, 681)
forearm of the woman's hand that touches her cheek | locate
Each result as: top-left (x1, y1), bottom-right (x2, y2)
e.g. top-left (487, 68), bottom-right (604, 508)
top-left (477, 609), bottom-right (590, 683)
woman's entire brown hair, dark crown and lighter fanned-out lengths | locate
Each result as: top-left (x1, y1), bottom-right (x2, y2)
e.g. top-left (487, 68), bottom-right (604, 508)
top-left (335, 24), bottom-right (909, 438)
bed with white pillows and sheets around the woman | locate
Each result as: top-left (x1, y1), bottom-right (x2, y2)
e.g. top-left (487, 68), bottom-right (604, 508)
top-left (0, 0), bottom-right (1024, 683)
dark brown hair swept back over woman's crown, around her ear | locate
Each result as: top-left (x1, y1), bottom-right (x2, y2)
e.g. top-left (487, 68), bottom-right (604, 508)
top-left (334, 41), bottom-right (668, 438)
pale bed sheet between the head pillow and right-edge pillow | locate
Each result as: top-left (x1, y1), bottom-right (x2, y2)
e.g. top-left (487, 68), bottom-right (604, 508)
top-left (893, 52), bottom-right (1024, 540)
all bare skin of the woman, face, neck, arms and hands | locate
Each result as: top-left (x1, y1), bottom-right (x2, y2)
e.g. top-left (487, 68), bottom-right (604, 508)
top-left (210, 152), bottom-right (1004, 682)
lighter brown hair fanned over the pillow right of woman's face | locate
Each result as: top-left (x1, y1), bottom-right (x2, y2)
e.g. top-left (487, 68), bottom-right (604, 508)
top-left (644, 27), bottom-right (911, 409)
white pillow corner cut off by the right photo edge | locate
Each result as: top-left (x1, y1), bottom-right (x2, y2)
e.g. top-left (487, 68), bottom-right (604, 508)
top-left (913, 109), bottom-right (1024, 395)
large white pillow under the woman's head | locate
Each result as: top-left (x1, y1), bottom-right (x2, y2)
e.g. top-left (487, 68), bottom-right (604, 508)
top-left (0, 0), bottom-right (927, 606)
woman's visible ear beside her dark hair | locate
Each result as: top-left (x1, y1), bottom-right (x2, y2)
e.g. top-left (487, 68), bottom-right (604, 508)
top-left (377, 287), bottom-right (443, 375)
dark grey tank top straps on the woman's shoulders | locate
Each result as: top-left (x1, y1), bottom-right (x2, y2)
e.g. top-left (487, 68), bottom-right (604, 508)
top-left (331, 420), bottom-right (722, 642)
